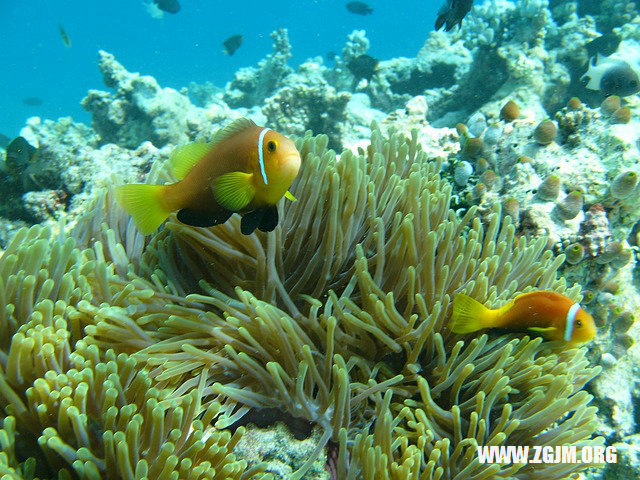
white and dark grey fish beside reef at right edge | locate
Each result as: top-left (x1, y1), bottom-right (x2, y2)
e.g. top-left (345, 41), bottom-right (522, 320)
top-left (580, 54), bottom-right (640, 97)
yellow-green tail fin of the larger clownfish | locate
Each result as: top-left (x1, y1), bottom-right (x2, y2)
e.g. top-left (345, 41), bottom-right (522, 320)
top-left (116, 183), bottom-right (171, 235)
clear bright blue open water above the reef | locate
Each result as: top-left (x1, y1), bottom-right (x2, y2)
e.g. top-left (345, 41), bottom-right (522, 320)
top-left (0, 0), bottom-right (444, 137)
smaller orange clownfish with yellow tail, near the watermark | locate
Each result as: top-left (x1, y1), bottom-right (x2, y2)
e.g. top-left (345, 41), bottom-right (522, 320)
top-left (451, 290), bottom-right (596, 345)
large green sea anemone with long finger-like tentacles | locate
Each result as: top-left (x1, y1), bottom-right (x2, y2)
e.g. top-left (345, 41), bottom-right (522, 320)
top-left (0, 125), bottom-right (602, 480)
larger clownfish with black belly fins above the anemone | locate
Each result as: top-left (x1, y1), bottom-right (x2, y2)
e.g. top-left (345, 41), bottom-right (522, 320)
top-left (116, 118), bottom-right (300, 235)
